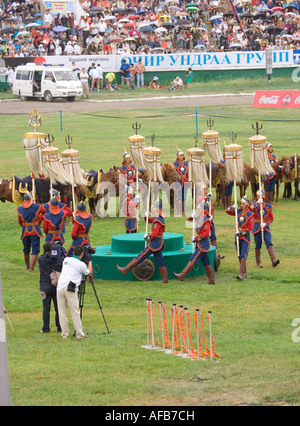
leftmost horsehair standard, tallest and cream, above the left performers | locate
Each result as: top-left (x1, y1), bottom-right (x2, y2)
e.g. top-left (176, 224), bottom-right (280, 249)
top-left (23, 132), bottom-right (49, 177)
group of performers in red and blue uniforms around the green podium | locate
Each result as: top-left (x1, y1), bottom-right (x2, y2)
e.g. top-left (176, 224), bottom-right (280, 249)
top-left (17, 144), bottom-right (279, 284)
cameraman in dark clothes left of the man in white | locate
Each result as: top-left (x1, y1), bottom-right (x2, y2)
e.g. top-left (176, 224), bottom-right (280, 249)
top-left (38, 243), bottom-right (64, 333)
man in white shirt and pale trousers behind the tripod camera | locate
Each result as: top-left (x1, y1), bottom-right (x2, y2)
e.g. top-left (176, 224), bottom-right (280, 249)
top-left (57, 247), bottom-right (92, 339)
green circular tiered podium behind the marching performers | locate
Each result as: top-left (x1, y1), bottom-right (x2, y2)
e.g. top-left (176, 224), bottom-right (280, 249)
top-left (92, 232), bottom-right (216, 281)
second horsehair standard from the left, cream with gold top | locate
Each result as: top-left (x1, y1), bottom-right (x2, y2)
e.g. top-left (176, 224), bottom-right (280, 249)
top-left (42, 146), bottom-right (68, 185)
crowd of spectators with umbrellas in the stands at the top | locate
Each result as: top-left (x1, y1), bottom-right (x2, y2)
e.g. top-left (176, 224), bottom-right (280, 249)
top-left (0, 0), bottom-right (300, 57)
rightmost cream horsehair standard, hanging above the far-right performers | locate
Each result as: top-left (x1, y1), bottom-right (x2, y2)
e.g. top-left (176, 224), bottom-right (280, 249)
top-left (249, 135), bottom-right (273, 175)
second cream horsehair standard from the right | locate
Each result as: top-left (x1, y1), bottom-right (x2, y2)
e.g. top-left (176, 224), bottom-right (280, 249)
top-left (224, 143), bottom-right (244, 182)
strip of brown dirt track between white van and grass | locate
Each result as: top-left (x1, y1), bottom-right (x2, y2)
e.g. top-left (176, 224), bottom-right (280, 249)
top-left (0, 93), bottom-right (254, 115)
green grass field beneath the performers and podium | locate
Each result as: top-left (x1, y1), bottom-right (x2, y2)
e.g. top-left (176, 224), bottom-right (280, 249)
top-left (0, 88), bottom-right (300, 406)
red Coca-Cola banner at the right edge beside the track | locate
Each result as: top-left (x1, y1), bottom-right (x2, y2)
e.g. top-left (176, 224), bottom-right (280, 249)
top-left (253, 90), bottom-right (300, 108)
